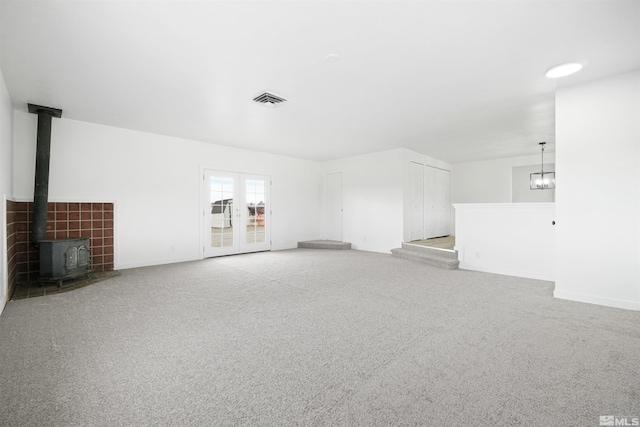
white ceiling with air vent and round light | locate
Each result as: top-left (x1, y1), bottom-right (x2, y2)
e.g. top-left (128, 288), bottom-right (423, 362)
top-left (0, 0), bottom-right (640, 163)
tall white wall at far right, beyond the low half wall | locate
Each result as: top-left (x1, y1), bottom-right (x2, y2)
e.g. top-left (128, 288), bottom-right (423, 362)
top-left (554, 71), bottom-right (640, 310)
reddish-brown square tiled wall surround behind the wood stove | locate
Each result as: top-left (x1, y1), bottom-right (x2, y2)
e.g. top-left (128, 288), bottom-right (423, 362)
top-left (7, 200), bottom-right (113, 295)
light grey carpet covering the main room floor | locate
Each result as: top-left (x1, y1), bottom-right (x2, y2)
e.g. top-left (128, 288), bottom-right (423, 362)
top-left (0, 249), bottom-right (640, 426)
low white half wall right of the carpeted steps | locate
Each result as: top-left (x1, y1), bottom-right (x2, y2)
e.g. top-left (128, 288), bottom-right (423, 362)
top-left (454, 203), bottom-right (555, 280)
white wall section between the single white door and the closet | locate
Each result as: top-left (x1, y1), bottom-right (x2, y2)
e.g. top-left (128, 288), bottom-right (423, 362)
top-left (323, 149), bottom-right (404, 253)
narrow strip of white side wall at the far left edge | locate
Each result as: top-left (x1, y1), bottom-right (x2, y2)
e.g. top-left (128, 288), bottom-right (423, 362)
top-left (0, 67), bottom-right (13, 314)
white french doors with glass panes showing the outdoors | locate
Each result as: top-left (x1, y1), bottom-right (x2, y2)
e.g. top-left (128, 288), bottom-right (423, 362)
top-left (203, 170), bottom-right (271, 258)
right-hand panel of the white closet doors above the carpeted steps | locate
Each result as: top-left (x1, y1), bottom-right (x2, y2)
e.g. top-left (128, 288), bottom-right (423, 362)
top-left (424, 166), bottom-right (451, 239)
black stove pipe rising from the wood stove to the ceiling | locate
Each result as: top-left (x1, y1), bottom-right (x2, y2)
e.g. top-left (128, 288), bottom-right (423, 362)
top-left (28, 104), bottom-right (62, 247)
